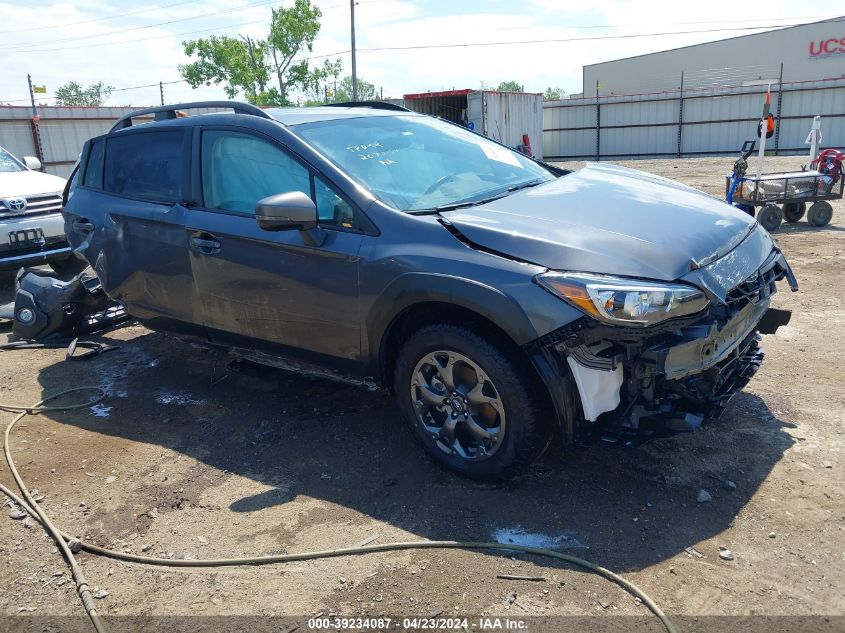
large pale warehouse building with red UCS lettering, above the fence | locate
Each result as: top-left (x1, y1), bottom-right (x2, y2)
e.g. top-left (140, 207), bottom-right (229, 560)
top-left (583, 16), bottom-right (845, 97)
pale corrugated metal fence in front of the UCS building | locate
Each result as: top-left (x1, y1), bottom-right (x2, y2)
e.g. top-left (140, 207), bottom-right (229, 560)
top-left (543, 78), bottom-right (845, 161)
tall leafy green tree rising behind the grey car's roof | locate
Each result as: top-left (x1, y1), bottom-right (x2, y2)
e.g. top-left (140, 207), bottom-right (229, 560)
top-left (179, 0), bottom-right (322, 105)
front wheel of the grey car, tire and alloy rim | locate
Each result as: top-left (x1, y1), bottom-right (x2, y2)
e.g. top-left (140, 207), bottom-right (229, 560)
top-left (394, 325), bottom-right (551, 479)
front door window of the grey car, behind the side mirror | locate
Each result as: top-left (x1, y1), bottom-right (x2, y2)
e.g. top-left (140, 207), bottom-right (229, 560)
top-left (202, 130), bottom-right (311, 215)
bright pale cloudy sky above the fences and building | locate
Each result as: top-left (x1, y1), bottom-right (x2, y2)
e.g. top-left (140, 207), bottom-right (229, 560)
top-left (0, 0), bottom-right (835, 105)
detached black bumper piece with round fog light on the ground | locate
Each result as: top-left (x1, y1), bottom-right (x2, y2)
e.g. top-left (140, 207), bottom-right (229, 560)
top-left (12, 270), bottom-right (129, 341)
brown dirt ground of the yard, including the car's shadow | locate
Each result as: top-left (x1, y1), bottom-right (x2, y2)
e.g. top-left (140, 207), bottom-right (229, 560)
top-left (0, 158), bottom-right (845, 630)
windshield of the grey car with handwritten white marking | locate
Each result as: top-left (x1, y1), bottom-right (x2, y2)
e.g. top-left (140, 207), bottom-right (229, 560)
top-left (294, 115), bottom-right (555, 211)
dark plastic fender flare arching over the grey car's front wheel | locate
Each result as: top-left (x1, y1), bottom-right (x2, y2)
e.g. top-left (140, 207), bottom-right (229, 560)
top-left (365, 272), bottom-right (538, 380)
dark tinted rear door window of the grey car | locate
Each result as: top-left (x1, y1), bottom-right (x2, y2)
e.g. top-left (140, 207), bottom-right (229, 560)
top-left (104, 130), bottom-right (184, 203)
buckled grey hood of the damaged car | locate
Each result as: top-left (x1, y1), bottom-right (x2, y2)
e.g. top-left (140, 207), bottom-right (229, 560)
top-left (443, 163), bottom-right (755, 281)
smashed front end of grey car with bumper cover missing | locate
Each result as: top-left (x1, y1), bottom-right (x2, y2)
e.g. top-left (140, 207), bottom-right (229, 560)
top-left (533, 248), bottom-right (798, 446)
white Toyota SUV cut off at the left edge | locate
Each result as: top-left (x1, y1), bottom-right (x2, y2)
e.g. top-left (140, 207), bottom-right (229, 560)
top-left (0, 147), bottom-right (80, 275)
